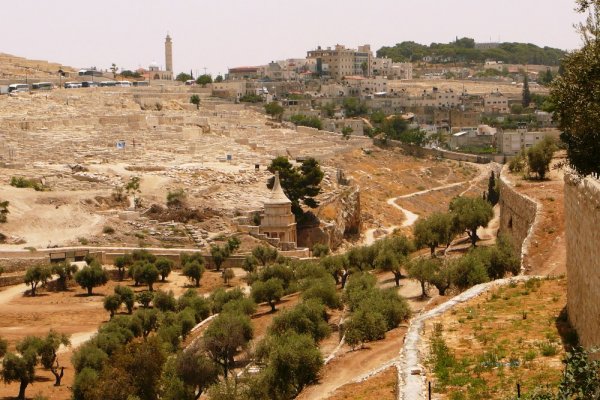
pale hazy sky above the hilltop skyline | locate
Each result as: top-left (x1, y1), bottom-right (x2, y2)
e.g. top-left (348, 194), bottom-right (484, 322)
top-left (0, 0), bottom-right (584, 75)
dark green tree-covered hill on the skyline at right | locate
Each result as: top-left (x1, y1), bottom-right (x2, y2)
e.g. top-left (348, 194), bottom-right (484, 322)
top-left (377, 38), bottom-right (566, 66)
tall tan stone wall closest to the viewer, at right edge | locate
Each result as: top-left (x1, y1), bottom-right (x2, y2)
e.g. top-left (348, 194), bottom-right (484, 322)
top-left (565, 172), bottom-right (600, 347)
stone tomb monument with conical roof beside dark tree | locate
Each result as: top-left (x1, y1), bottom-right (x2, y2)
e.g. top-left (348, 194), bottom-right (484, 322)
top-left (260, 173), bottom-right (297, 250)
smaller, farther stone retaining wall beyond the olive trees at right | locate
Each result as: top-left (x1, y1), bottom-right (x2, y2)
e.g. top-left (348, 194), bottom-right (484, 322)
top-left (498, 167), bottom-right (539, 268)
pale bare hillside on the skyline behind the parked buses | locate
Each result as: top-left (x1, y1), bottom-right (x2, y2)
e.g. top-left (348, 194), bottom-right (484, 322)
top-left (0, 53), bottom-right (77, 79)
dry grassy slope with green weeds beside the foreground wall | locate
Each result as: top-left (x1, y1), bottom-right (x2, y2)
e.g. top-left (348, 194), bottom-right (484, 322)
top-left (424, 279), bottom-right (573, 400)
